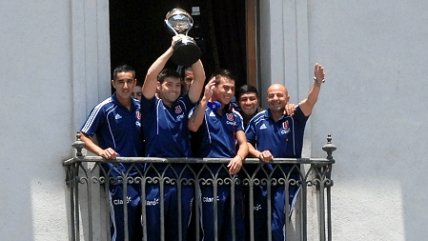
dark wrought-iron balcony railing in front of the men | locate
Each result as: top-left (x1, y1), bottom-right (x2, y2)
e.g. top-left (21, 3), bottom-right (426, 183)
top-left (63, 135), bottom-right (336, 241)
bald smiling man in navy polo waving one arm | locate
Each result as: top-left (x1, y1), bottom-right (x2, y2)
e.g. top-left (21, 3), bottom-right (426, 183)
top-left (245, 64), bottom-right (324, 241)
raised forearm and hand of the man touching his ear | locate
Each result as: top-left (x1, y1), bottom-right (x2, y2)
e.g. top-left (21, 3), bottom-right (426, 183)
top-left (187, 77), bottom-right (215, 132)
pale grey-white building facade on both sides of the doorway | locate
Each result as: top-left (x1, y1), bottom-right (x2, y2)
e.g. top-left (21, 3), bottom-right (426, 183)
top-left (0, 0), bottom-right (428, 241)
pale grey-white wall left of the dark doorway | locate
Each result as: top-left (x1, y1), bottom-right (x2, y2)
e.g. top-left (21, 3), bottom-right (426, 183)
top-left (0, 0), bottom-right (110, 241)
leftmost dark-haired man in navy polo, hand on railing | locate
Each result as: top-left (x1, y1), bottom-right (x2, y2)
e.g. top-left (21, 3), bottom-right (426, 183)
top-left (80, 65), bottom-right (143, 241)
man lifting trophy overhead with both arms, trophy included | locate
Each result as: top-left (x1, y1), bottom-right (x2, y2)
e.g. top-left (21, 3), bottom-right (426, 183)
top-left (141, 7), bottom-right (205, 241)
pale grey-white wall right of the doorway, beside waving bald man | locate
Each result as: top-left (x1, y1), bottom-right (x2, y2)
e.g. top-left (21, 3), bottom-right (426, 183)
top-left (261, 0), bottom-right (428, 241)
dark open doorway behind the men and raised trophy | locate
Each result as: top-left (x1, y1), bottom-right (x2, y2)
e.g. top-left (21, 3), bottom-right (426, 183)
top-left (109, 0), bottom-right (247, 87)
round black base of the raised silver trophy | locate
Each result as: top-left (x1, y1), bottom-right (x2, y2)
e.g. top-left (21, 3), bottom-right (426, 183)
top-left (171, 38), bottom-right (201, 67)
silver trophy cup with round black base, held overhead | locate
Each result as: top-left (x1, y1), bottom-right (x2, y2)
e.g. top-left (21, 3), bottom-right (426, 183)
top-left (165, 8), bottom-right (201, 67)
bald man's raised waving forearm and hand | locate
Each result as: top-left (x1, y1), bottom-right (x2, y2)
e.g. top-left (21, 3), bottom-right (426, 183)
top-left (299, 63), bottom-right (324, 116)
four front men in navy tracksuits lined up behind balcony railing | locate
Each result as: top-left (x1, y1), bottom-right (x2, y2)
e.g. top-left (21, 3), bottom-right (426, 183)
top-left (81, 35), bottom-right (324, 241)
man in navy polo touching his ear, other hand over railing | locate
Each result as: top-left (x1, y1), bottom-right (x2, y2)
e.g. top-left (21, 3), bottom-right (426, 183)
top-left (188, 70), bottom-right (248, 241)
